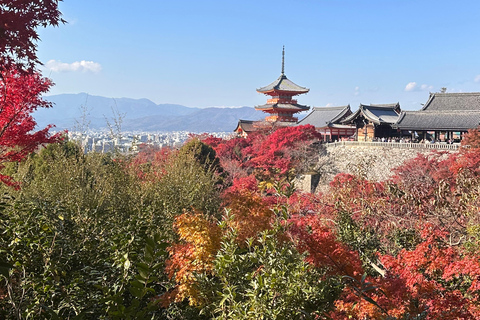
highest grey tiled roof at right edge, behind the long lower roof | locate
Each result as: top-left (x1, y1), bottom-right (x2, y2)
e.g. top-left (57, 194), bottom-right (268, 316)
top-left (422, 92), bottom-right (480, 112)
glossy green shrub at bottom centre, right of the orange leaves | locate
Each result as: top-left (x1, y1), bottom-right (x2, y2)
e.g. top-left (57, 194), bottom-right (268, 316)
top-left (201, 221), bottom-right (341, 319)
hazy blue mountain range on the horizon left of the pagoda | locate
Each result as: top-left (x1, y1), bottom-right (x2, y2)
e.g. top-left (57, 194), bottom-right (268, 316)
top-left (34, 93), bottom-right (265, 132)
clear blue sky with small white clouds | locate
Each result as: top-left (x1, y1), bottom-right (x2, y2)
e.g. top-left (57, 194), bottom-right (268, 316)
top-left (38, 0), bottom-right (480, 110)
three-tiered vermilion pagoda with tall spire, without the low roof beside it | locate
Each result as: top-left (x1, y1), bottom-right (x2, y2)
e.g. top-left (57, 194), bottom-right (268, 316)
top-left (255, 46), bottom-right (310, 123)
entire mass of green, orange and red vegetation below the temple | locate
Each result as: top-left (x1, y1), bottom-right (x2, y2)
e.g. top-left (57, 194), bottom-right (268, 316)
top-left (0, 126), bottom-right (480, 319)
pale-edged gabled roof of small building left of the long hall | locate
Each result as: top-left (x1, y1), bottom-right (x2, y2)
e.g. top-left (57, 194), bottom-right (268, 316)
top-left (342, 102), bottom-right (400, 124)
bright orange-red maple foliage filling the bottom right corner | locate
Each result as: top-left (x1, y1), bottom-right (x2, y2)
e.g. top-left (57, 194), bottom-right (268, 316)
top-left (333, 225), bottom-right (480, 319)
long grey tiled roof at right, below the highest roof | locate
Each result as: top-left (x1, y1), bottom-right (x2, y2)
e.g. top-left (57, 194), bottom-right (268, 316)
top-left (394, 109), bottom-right (480, 131)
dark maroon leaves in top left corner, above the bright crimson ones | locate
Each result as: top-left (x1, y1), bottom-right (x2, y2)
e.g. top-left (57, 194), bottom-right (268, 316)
top-left (0, 0), bottom-right (65, 71)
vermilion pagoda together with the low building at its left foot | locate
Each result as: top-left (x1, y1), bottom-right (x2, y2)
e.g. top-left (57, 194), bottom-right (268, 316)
top-left (234, 47), bottom-right (310, 136)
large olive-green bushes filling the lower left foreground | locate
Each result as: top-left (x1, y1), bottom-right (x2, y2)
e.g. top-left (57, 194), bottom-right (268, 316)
top-left (0, 142), bottom-right (166, 319)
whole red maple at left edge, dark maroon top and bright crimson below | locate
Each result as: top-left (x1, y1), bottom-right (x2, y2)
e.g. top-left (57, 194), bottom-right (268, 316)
top-left (0, 0), bottom-right (64, 184)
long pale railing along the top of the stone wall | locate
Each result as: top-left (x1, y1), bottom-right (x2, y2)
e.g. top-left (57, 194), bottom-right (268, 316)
top-left (325, 141), bottom-right (460, 150)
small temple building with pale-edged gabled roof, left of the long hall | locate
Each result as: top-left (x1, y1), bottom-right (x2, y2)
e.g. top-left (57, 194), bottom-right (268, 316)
top-left (341, 103), bottom-right (401, 141)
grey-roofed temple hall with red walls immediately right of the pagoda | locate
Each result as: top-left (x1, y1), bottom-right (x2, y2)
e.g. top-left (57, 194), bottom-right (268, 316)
top-left (298, 105), bottom-right (356, 142)
